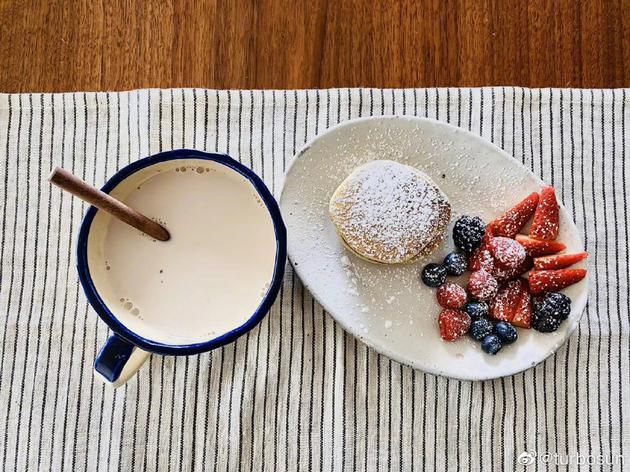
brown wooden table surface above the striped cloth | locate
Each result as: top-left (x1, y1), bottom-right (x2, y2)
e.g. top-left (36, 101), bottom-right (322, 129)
top-left (0, 0), bottom-right (630, 92)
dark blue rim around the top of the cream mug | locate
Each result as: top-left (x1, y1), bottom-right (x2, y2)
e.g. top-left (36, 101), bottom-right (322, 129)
top-left (77, 149), bottom-right (287, 356)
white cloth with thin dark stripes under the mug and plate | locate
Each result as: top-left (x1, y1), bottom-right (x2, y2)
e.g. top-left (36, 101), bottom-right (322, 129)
top-left (0, 87), bottom-right (630, 471)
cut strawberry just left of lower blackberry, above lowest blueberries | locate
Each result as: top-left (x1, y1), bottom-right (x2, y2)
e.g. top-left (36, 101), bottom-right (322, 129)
top-left (490, 278), bottom-right (532, 328)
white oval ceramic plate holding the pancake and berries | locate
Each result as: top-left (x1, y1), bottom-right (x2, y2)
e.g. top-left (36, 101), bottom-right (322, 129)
top-left (280, 117), bottom-right (588, 380)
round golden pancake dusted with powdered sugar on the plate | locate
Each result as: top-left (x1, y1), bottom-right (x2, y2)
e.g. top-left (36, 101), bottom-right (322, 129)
top-left (329, 160), bottom-right (451, 264)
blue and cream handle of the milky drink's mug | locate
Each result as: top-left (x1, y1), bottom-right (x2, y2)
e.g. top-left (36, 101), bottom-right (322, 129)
top-left (94, 333), bottom-right (150, 388)
